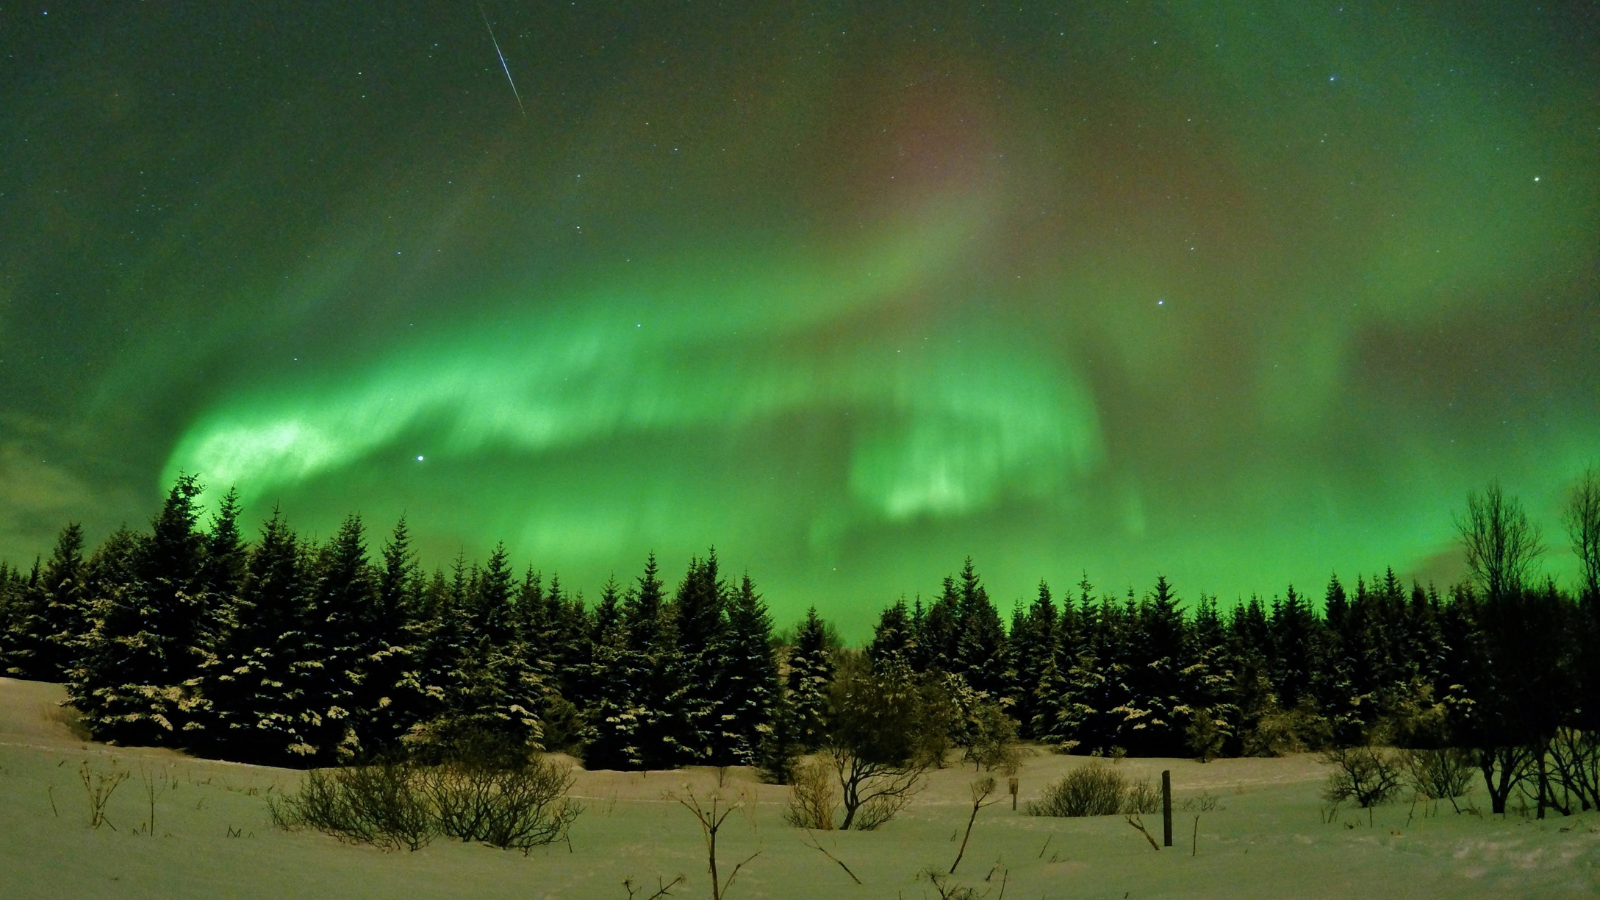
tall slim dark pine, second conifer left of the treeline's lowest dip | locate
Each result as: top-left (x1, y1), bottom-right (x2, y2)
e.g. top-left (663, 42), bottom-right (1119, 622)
top-left (722, 573), bottom-right (779, 765)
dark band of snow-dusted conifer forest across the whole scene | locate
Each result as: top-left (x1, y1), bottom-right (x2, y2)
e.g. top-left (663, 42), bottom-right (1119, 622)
top-left (0, 468), bottom-right (1600, 815)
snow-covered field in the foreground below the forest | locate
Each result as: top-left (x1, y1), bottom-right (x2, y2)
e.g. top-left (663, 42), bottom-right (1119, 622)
top-left (0, 679), bottom-right (1600, 900)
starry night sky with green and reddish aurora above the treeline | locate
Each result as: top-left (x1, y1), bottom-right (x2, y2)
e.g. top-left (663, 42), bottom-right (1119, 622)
top-left (0, 0), bottom-right (1600, 637)
